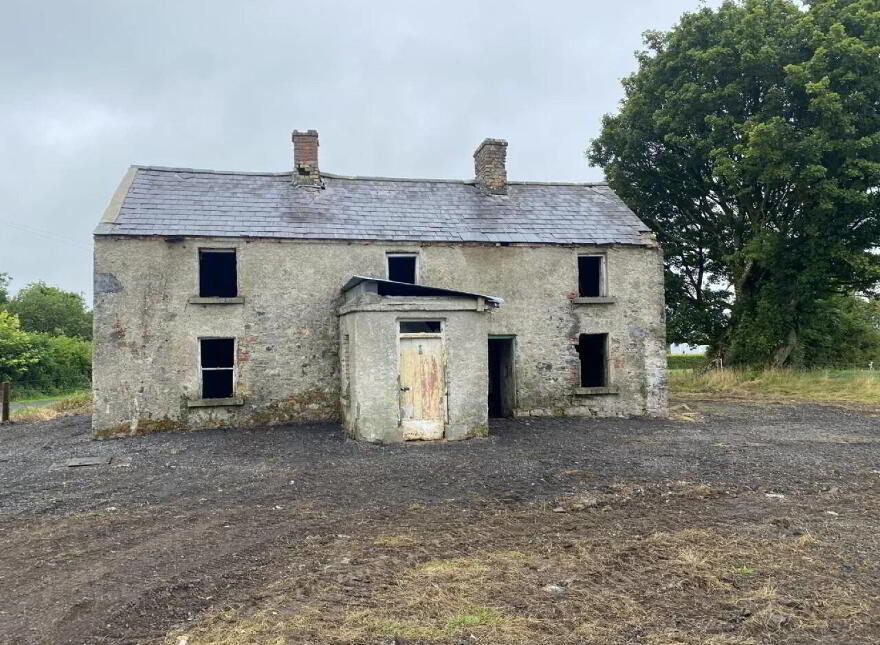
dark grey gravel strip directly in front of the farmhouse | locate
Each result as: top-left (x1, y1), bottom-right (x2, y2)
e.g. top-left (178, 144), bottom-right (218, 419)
top-left (0, 403), bottom-right (880, 516)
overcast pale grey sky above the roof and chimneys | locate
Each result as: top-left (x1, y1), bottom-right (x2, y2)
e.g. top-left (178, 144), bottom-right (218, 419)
top-left (0, 0), bottom-right (717, 301)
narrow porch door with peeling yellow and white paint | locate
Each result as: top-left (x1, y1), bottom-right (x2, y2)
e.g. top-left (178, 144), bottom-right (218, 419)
top-left (399, 335), bottom-right (446, 440)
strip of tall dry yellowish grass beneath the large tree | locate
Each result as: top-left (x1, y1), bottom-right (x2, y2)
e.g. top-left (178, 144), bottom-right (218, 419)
top-left (669, 369), bottom-right (880, 405)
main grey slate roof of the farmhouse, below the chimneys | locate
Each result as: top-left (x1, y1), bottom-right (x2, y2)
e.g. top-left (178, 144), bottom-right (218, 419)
top-left (95, 166), bottom-right (648, 244)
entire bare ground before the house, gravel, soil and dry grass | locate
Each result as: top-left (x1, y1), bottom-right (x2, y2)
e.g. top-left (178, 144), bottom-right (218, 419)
top-left (0, 401), bottom-right (880, 645)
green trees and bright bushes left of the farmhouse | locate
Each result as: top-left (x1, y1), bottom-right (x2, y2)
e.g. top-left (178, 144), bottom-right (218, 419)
top-left (0, 273), bottom-right (93, 399)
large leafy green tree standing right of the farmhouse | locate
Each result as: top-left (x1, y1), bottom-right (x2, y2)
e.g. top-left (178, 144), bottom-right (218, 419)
top-left (589, 0), bottom-right (880, 365)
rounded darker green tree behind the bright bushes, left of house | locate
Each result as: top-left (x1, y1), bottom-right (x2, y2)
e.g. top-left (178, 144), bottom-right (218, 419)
top-left (4, 282), bottom-right (92, 340)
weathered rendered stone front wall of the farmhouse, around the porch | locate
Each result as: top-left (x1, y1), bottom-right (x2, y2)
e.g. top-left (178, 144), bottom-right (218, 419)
top-left (94, 236), bottom-right (665, 436)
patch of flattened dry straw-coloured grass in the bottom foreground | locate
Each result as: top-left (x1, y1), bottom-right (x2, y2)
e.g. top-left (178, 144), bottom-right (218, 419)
top-left (166, 511), bottom-right (870, 645)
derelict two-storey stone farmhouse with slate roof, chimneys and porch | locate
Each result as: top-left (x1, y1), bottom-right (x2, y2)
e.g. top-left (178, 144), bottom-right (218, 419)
top-left (93, 130), bottom-right (666, 443)
